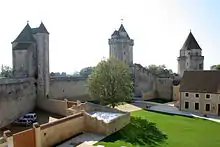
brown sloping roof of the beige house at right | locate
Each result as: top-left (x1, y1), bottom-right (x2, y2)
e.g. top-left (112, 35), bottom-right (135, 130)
top-left (180, 70), bottom-right (220, 93)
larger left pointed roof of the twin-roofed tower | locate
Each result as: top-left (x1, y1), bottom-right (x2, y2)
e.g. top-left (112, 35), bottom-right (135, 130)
top-left (13, 23), bottom-right (35, 42)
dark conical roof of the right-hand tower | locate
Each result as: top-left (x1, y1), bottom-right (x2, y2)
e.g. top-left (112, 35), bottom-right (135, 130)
top-left (181, 32), bottom-right (201, 50)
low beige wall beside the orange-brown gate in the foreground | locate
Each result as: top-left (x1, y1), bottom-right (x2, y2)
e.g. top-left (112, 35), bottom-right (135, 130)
top-left (40, 113), bottom-right (85, 147)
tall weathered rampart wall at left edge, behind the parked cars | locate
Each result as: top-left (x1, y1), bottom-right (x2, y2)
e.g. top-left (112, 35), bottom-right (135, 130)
top-left (0, 78), bottom-right (36, 128)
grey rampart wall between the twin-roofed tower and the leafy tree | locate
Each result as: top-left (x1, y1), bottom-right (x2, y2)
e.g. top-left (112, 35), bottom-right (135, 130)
top-left (49, 77), bottom-right (90, 101)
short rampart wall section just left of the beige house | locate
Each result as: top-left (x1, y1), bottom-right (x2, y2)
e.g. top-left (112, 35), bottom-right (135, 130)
top-left (156, 78), bottom-right (173, 100)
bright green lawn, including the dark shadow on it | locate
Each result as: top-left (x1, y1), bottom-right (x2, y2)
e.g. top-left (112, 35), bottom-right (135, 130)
top-left (97, 110), bottom-right (220, 147)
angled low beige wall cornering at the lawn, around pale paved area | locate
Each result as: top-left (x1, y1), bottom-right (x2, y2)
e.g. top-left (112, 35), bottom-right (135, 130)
top-left (83, 112), bottom-right (130, 135)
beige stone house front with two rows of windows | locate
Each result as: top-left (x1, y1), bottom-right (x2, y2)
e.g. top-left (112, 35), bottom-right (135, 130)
top-left (180, 92), bottom-right (220, 116)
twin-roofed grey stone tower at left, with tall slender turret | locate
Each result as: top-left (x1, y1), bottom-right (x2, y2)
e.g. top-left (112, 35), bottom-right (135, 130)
top-left (12, 22), bottom-right (50, 97)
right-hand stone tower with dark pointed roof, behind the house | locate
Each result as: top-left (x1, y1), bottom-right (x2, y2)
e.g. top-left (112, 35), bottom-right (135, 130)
top-left (177, 31), bottom-right (204, 77)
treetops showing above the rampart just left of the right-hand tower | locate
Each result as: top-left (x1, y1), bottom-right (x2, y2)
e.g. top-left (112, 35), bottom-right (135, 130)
top-left (145, 64), bottom-right (173, 77)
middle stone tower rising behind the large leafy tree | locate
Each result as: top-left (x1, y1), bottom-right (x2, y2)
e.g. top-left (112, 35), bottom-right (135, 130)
top-left (108, 24), bottom-right (134, 66)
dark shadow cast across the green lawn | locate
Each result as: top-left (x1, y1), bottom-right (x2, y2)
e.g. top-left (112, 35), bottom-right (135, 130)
top-left (101, 117), bottom-right (167, 147)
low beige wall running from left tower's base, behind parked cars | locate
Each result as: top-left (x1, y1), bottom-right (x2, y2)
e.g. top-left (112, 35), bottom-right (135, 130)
top-left (37, 98), bottom-right (67, 116)
